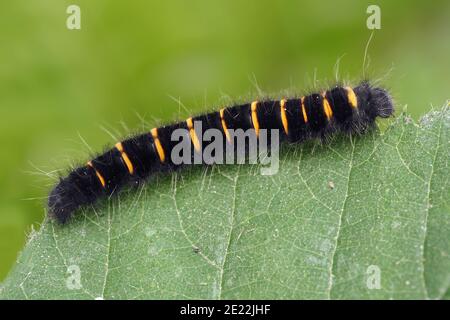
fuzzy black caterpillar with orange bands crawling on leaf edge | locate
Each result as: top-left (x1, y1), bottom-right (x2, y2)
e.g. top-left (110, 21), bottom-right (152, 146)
top-left (48, 81), bottom-right (394, 223)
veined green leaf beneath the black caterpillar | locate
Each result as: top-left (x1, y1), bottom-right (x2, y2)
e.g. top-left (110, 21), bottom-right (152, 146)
top-left (0, 107), bottom-right (450, 299)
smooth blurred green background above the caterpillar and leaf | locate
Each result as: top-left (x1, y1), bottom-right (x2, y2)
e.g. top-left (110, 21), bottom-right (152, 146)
top-left (0, 0), bottom-right (450, 281)
